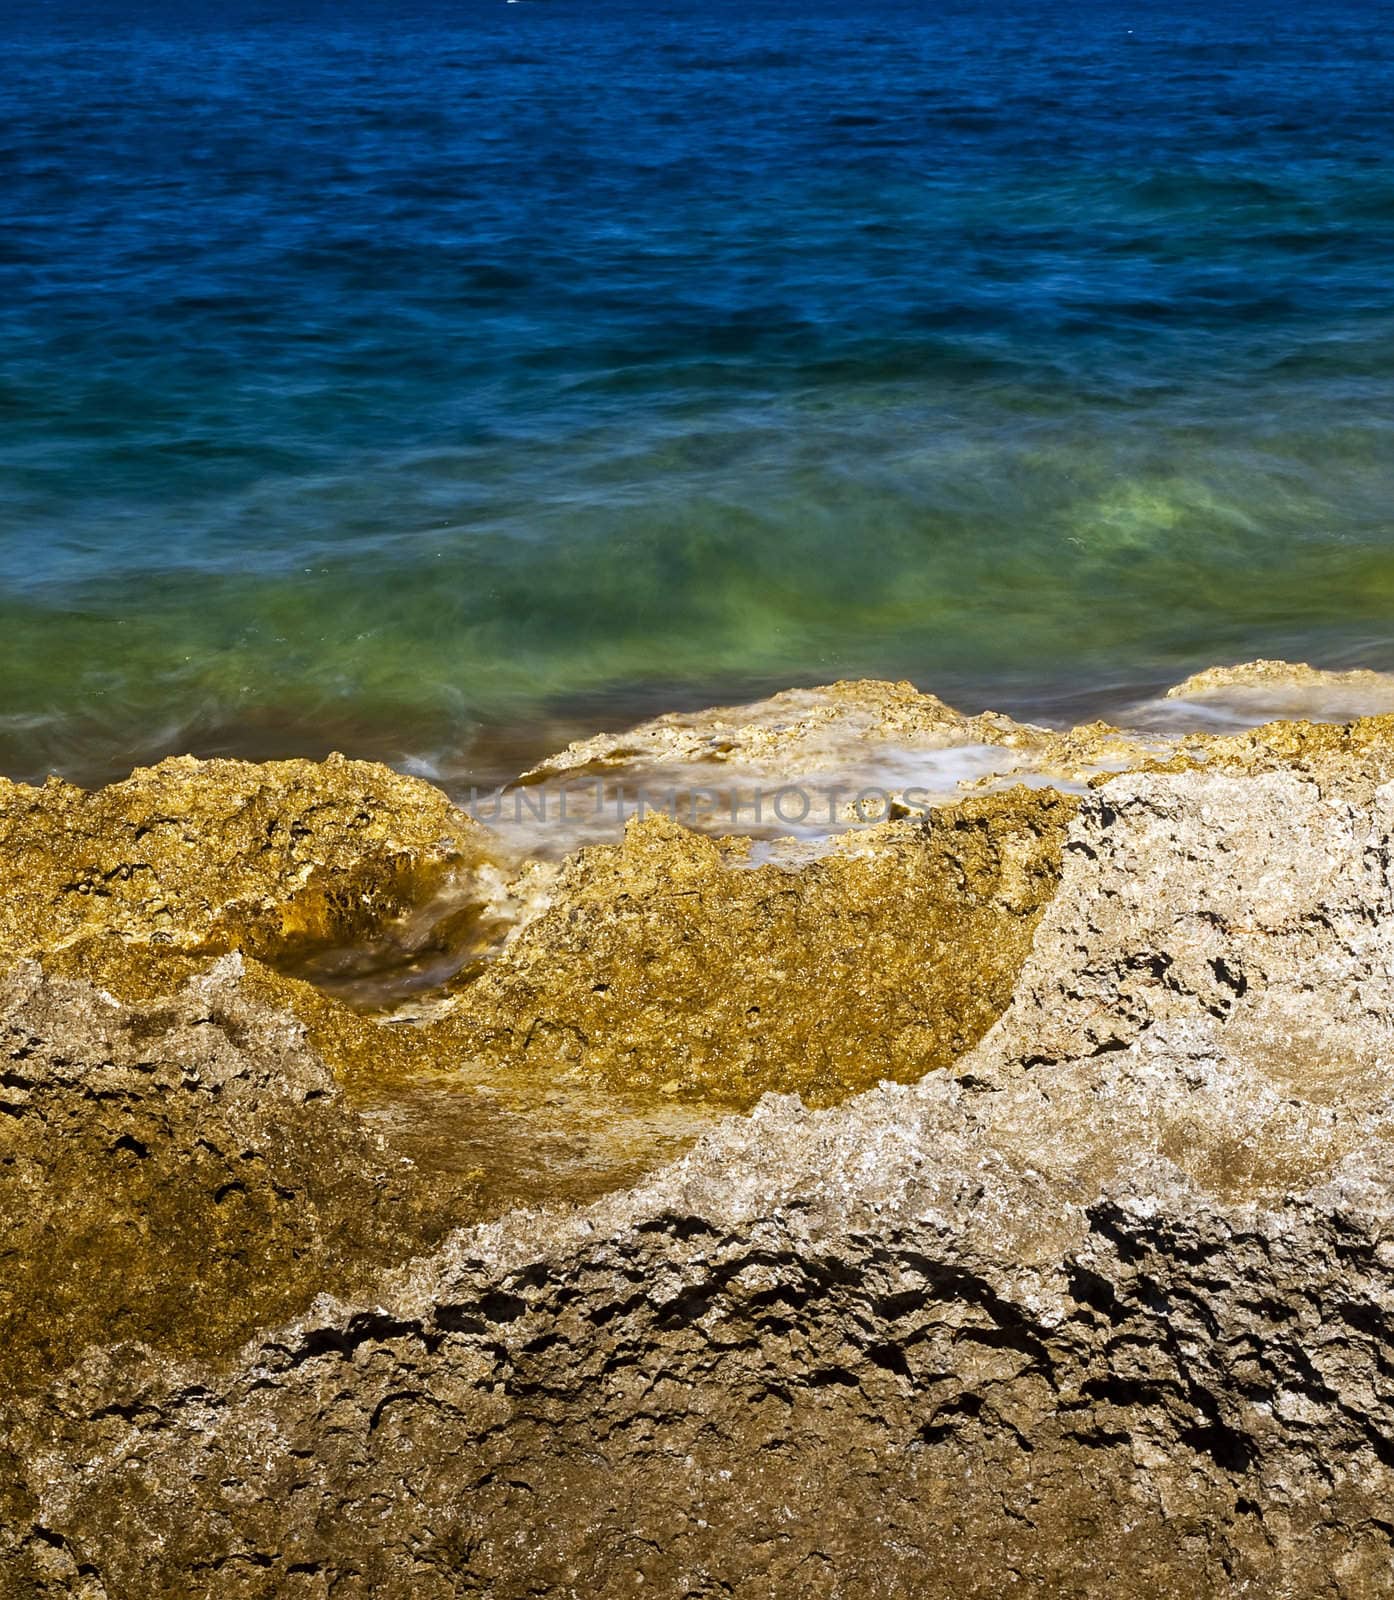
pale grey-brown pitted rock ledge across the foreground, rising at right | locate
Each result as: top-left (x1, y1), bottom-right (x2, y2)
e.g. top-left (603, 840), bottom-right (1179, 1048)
top-left (5, 726), bottom-right (1394, 1600)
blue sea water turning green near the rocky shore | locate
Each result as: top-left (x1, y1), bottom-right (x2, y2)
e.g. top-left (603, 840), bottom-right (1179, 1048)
top-left (0, 0), bottom-right (1394, 776)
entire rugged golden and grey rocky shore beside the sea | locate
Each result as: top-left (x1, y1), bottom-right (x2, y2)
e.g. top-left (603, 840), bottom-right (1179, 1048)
top-left (0, 662), bottom-right (1394, 1600)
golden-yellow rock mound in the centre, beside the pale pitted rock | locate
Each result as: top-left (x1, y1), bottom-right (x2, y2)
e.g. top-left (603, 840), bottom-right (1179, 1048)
top-left (437, 789), bottom-right (1076, 1106)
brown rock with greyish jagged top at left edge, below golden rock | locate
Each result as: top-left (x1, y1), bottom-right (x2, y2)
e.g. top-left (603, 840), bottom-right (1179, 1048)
top-left (0, 957), bottom-right (457, 1395)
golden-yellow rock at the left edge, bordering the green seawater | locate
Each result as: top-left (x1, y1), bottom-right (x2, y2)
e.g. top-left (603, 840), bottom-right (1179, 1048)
top-left (0, 757), bottom-right (488, 962)
